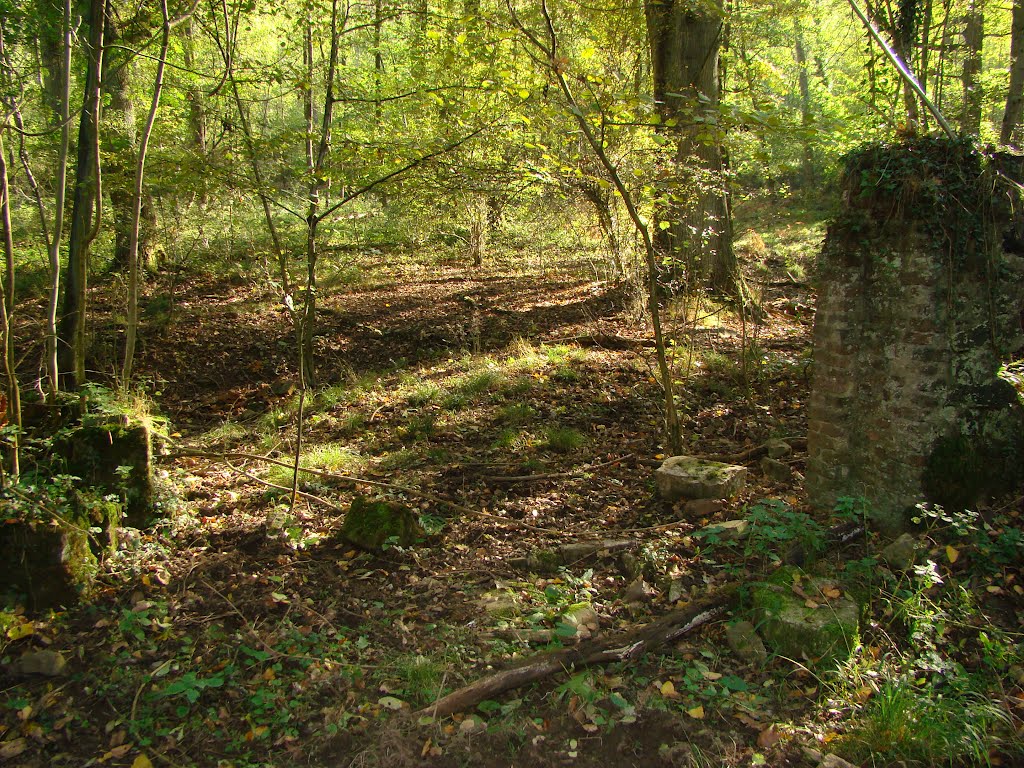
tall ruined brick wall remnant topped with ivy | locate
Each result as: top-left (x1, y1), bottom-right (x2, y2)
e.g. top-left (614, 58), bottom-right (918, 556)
top-left (807, 138), bottom-right (1024, 528)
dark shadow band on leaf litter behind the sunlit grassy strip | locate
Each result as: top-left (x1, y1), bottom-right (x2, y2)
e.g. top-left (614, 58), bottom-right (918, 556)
top-left (139, 269), bottom-right (627, 427)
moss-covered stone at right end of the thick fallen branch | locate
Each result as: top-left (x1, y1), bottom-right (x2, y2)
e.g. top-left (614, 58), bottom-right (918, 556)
top-left (753, 566), bottom-right (860, 668)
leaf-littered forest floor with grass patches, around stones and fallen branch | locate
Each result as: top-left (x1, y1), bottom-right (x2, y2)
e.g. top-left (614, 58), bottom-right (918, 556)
top-left (0, 199), bottom-right (1024, 768)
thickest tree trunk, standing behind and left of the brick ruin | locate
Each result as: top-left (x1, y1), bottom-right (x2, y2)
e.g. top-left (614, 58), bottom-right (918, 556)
top-left (644, 0), bottom-right (736, 293)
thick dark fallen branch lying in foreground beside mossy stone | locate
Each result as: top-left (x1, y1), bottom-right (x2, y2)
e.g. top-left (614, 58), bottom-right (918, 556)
top-left (417, 584), bottom-right (739, 718)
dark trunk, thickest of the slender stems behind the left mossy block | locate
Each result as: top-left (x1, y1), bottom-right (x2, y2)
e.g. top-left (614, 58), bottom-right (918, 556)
top-left (57, 0), bottom-right (105, 389)
